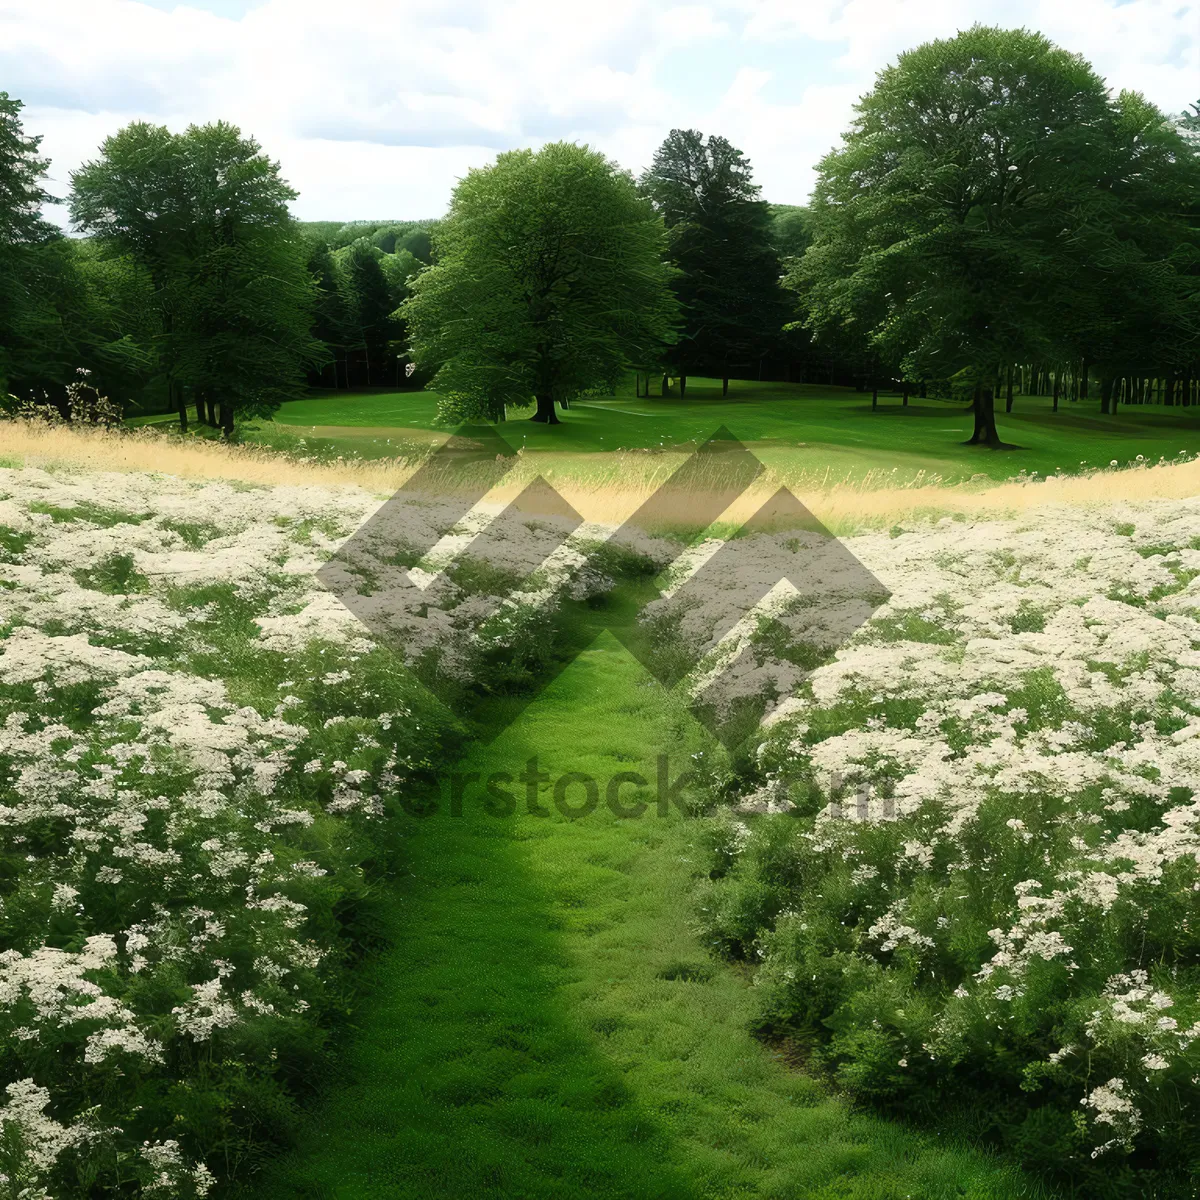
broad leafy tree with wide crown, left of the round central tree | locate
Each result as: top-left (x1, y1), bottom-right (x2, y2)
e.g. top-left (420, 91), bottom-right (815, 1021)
top-left (71, 121), bottom-right (320, 433)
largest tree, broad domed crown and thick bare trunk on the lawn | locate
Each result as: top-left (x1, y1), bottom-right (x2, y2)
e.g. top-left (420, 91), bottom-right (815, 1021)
top-left (796, 25), bottom-right (1114, 445)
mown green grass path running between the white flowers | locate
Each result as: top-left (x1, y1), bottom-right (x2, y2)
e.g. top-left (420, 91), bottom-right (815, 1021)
top-left (253, 637), bottom-right (1039, 1200)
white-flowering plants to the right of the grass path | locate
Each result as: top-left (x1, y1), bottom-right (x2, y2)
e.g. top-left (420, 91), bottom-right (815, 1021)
top-left (702, 500), bottom-right (1200, 1195)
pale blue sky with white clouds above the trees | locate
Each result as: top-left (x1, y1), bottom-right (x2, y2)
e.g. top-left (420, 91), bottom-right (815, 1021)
top-left (0, 0), bottom-right (1200, 220)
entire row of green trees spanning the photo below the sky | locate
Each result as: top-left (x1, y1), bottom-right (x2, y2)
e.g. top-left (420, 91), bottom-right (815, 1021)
top-left (0, 26), bottom-right (1200, 445)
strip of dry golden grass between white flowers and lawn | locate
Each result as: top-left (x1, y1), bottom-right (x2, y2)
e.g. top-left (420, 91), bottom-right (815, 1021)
top-left (0, 421), bottom-right (1200, 533)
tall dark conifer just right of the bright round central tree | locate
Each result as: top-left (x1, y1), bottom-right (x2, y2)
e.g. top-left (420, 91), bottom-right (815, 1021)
top-left (641, 130), bottom-right (788, 390)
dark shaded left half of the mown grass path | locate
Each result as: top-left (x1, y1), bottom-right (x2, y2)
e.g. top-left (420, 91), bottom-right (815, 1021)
top-left (251, 657), bottom-right (694, 1200)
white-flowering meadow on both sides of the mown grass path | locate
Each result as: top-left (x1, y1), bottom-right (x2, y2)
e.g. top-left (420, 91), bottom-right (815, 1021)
top-left (0, 453), bottom-right (1200, 1200)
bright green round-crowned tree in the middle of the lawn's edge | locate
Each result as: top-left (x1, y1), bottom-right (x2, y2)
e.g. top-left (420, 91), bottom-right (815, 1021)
top-left (401, 142), bottom-right (676, 425)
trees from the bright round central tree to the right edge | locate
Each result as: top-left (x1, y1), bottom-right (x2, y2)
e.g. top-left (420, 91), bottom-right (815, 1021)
top-left (404, 26), bottom-right (1200, 434)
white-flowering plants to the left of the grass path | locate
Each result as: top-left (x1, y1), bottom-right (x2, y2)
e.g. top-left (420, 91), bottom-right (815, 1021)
top-left (0, 469), bottom-right (477, 1200)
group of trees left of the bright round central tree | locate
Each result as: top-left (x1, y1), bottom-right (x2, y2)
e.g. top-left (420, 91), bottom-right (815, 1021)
top-left (0, 94), bottom-right (437, 432)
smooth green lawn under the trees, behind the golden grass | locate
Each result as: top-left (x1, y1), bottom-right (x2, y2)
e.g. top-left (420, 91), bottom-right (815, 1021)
top-left (258, 379), bottom-right (1200, 480)
